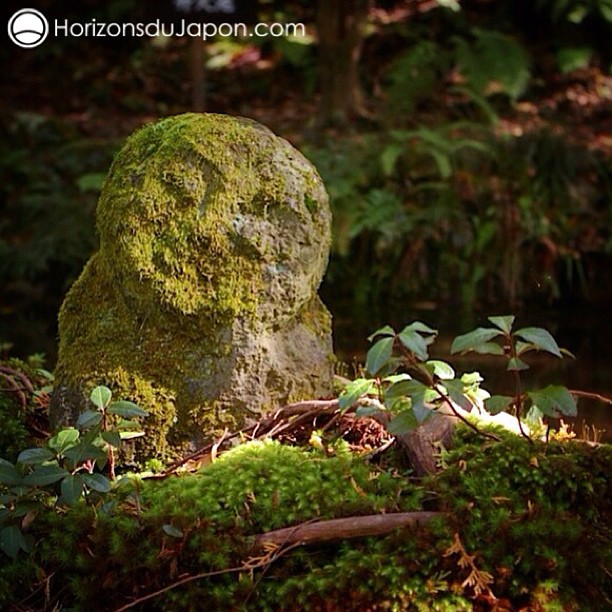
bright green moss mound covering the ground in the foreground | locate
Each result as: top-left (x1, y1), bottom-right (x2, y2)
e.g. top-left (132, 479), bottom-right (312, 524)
top-left (0, 430), bottom-right (612, 610)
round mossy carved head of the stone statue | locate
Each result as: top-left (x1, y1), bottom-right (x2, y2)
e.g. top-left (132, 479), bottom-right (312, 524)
top-left (98, 114), bottom-right (331, 326)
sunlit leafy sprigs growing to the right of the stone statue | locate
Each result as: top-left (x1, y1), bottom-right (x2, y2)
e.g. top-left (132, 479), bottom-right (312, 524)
top-left (339, 316), bottom-right (576, 439)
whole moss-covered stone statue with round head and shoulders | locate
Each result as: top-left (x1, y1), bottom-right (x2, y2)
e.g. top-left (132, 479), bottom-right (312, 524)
top-left (52, 114), bottom-right (332, 454)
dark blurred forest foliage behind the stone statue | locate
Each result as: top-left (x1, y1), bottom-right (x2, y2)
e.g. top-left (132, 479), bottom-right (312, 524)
top-left (0, 0), bottom-right (612, 368)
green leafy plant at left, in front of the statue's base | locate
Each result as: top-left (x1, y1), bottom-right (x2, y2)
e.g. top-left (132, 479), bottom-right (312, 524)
top-left (0, 386), bottom-right (148, 558)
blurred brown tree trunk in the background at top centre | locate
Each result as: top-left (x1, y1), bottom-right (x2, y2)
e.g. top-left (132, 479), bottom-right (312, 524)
top-left (317, 0), bottom-right (371, 127)
